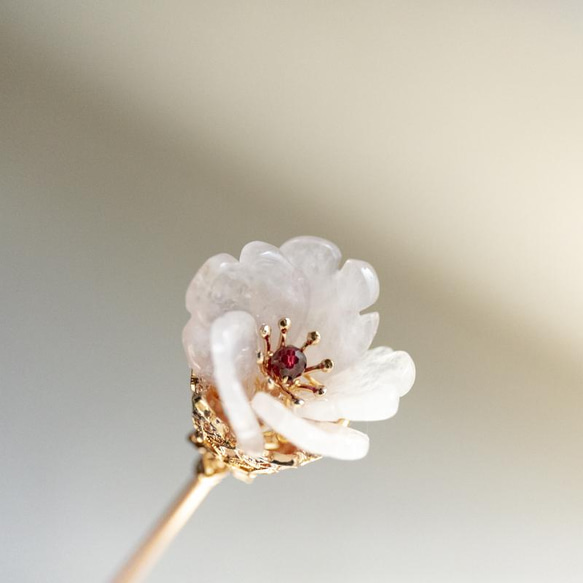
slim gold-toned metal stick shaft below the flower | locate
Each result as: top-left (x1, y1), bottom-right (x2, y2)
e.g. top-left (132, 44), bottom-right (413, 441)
top-left (113, 468), bottom-right (226, 583)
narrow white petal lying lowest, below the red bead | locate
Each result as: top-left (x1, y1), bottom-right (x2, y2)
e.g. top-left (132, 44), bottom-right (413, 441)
top-left (251, 393), bottom-right (369, 460)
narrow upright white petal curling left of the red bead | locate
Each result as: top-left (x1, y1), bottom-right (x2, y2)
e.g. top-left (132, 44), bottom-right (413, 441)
top-left (211, 312), bottom-right (264, 456)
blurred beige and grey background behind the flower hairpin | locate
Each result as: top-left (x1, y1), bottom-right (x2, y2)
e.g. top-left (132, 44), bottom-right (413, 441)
top-left (0, 0), bottom-right (583, 583)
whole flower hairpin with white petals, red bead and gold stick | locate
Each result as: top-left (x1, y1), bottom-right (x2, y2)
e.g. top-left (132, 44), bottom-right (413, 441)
top-left (117, 237), bottom-right (415, 582)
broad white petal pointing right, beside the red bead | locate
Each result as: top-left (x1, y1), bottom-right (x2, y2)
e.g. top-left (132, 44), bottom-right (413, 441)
top-left (298, 346), bottom-right (415, 421)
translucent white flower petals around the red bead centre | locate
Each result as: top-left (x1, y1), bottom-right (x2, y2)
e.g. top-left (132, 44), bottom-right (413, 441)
top-left (183, 237), bottom-right (415, 459)
